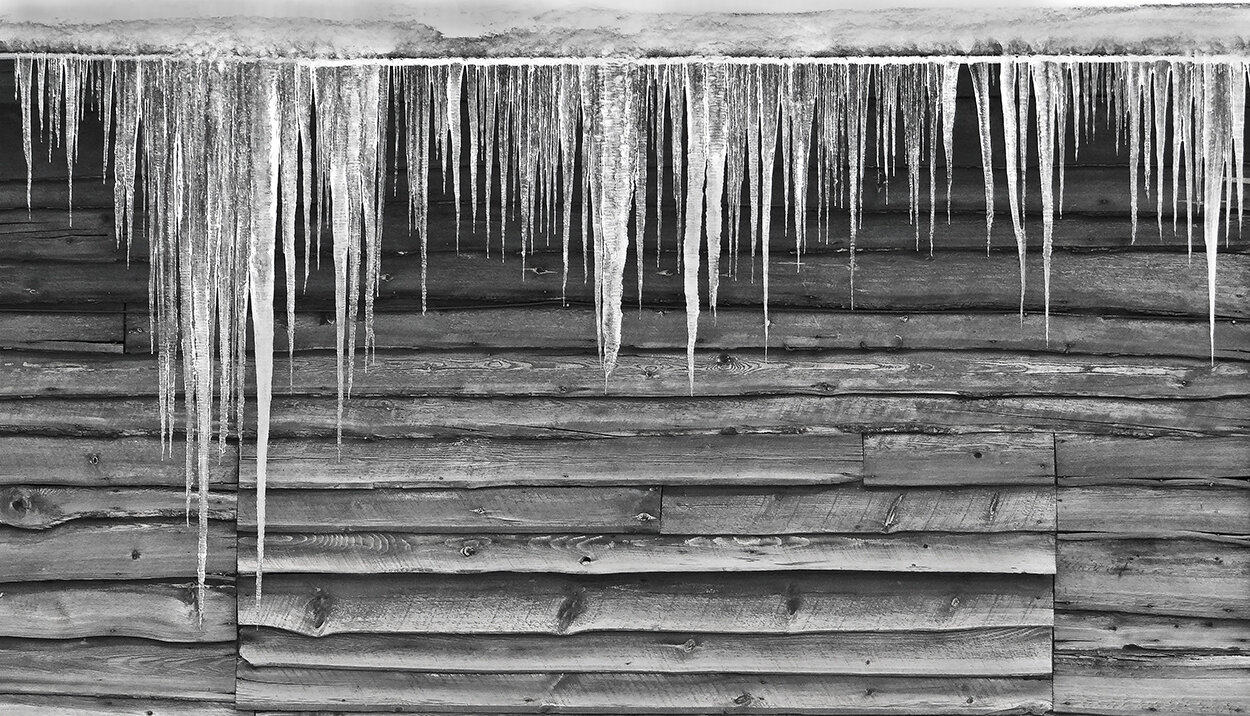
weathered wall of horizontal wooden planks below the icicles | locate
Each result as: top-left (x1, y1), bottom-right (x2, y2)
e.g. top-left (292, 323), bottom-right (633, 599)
top-left (0, 61), bottom-right (1250, 716)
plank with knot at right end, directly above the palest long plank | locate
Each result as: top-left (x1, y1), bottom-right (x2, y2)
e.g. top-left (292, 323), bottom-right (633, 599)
top-left (239, 487), bottom-right (660, 534)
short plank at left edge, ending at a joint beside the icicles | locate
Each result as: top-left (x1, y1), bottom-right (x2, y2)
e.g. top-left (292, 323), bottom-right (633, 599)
top-left (0, 307), bottom-right (126, 354)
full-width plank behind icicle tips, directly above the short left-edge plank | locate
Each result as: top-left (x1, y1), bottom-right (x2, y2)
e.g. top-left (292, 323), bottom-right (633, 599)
top-left (0, 252), bottom-right (1250, 324)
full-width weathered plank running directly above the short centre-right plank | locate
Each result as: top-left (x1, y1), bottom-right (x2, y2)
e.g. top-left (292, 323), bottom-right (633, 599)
top-left (0, 395), bottom-right (1250, 434)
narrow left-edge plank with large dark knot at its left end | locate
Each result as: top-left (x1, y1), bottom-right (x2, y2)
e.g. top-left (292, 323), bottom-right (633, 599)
top-left (0, 485), bottom-right (235, 530)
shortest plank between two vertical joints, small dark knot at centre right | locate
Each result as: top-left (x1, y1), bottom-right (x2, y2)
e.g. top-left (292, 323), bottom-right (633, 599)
top-left (864, 432), bottom-right (1055, 487)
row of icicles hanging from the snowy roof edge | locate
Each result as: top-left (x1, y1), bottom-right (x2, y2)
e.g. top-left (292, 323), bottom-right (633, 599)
top-left (7, 55), bottom-right (1248, 612)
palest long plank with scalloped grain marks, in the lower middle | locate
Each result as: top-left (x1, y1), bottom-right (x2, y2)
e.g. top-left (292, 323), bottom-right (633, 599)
top-left (239, 532), bottom-right (1055, 575)
